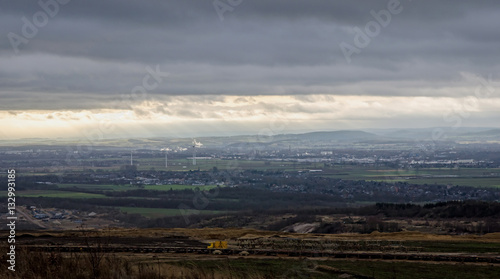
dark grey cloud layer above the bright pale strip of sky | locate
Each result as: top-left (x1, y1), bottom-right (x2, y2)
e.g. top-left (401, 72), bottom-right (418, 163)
top-left (0, 0), bottom-right (500, 109)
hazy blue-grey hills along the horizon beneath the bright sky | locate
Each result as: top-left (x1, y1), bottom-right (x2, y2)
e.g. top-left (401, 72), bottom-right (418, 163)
top-left (5, 127), bottom-right (500, 149)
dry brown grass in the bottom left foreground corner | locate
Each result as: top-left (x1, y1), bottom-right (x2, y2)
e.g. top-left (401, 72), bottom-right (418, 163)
top-left (0, 247), bottom-right (272, 279)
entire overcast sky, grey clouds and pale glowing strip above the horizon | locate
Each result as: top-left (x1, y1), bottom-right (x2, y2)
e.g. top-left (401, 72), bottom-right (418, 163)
top-left (0, 0), bottom-right (500, 138)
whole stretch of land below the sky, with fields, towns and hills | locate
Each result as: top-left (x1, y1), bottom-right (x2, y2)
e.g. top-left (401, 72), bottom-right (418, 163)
top-left (0, 129), bottom-right (500, 278)
